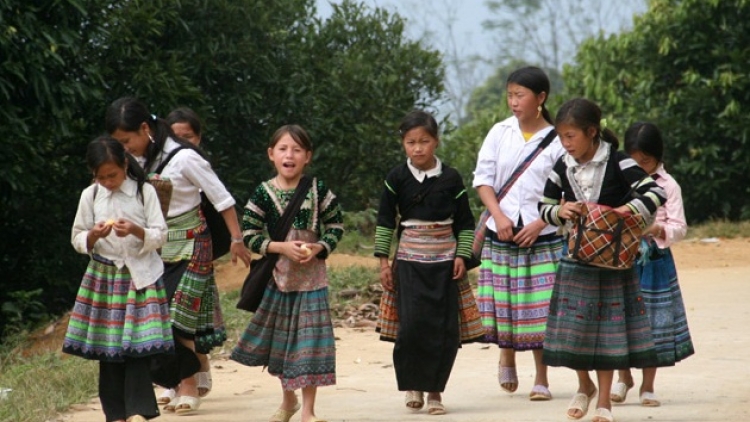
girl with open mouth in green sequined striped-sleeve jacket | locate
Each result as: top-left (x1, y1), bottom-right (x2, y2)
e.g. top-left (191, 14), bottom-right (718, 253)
top-left (231, 125), bottom-right (344, 422)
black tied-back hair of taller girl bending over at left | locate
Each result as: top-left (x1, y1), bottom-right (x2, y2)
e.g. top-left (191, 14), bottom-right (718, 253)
top-left (104, 97), bottom-right (208, 171)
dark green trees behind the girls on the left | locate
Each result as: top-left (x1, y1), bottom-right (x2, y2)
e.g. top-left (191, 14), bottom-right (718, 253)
top-left (0, 0), bottom-right (443, 338)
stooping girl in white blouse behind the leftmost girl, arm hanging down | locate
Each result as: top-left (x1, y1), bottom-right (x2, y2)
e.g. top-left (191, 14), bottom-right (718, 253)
top-left (105, 97), bottom-right (251, 414)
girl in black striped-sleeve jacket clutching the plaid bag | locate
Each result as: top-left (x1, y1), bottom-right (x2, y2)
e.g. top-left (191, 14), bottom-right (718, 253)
top-left (539, 98), bottom-right (665, 422)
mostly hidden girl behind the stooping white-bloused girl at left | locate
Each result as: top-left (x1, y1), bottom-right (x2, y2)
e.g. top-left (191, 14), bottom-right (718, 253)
top-left (164, 107), bottom-right (226, 398)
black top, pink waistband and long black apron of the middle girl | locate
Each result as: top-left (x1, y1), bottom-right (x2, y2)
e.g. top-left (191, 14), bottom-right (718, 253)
top-left (375, 160), bottom-right (483, 392)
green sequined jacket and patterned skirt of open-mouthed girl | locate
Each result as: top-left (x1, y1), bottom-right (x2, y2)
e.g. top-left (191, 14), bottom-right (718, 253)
top-left (231, 179), bottom-right (344, 390)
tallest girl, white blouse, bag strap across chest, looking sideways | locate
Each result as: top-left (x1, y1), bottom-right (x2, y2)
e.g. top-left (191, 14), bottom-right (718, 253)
top-left (473, 67), bottom-right (564, 400)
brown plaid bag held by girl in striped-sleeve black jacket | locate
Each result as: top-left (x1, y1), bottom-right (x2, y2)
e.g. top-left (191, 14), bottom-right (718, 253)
top-left (568, 202), bottom-right (646, 270)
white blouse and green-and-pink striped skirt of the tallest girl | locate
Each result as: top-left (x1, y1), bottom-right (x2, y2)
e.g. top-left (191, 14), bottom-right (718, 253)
top-left (473, 117), bottom-right (564, 351)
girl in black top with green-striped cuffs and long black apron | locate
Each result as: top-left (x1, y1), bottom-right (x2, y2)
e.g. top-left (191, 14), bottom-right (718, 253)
top-left (375, 111), bottom-right (482, 415)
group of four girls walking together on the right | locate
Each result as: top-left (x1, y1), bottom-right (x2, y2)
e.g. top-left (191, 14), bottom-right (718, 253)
top-left (375, 67), bottom-right (694, 422)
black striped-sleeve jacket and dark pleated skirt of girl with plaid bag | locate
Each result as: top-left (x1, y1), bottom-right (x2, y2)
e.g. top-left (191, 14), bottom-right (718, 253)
top-left (539, 140), bottom-right (665, 370)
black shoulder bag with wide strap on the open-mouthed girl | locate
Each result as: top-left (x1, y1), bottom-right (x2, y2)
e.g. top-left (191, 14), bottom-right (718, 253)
top-left (237, 176), bottom-right (312, 312)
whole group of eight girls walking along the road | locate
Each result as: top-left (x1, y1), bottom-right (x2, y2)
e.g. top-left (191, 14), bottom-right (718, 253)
top-left (63, 67), bottom-right (693, 422)
